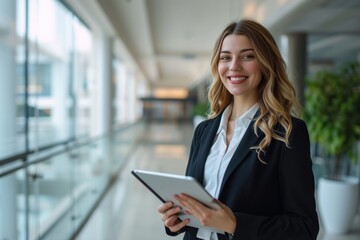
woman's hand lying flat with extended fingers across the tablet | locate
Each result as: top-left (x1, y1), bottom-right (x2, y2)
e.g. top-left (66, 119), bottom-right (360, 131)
top-left (175, 193), bottom-right (236, 233)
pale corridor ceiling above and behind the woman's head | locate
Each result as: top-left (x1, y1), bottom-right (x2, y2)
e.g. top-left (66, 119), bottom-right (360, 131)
top-left (96, 0), bottom-right (360, 88)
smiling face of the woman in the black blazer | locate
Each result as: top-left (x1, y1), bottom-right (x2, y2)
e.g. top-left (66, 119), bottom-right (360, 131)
top-left (218, 34), bottom-right (262, 99)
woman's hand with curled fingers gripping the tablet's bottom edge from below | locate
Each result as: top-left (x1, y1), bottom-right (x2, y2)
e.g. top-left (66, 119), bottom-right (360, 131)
top-left (158, 202), bottom-right (190, 232)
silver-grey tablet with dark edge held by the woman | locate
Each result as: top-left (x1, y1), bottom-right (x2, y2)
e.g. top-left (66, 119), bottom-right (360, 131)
top-left (131, 169), bottom-right (224, 233)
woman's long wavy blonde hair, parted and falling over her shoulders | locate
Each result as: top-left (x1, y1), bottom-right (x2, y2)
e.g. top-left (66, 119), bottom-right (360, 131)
top-left (208, 19), bottom-right (300, 163)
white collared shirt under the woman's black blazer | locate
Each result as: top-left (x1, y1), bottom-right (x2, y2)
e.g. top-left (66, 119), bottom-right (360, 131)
top-left (197, 104), bottom-right (259, 240)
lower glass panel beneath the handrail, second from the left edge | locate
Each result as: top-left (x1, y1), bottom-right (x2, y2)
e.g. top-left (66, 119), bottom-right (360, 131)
top-left (28, 154), bottom-right (74, 239)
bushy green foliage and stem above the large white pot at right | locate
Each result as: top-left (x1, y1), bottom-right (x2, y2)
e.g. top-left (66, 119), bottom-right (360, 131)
top-left (304, 62), bottom-right (360, 178)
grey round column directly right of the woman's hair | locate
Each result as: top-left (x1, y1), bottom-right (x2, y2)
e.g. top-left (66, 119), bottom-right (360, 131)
top-left (280, 33), bottom-right (307, 105)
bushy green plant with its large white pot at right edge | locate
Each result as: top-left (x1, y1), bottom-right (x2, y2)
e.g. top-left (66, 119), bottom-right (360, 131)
top-left (304, 62), bottom-right (360, 234)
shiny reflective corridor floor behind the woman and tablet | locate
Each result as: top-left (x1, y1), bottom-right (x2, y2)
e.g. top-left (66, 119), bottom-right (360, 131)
top-left (77, 122), bottom-right (360, 240)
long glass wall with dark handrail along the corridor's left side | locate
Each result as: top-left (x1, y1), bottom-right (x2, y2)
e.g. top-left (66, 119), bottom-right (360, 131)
top-left (0, 0), bottom-right (146, 240)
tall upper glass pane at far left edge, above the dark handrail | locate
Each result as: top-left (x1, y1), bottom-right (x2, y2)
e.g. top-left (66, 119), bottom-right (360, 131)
top-left (0, 0), bottom-right (25, 158)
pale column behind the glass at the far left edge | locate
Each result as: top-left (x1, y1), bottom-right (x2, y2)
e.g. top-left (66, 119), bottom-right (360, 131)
top-left (0, 0), bottom-right (18, 239)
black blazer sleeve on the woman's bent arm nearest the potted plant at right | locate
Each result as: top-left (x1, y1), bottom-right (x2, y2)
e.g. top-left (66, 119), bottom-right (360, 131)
top-left (229, 119), bottom-right (319, 240)
